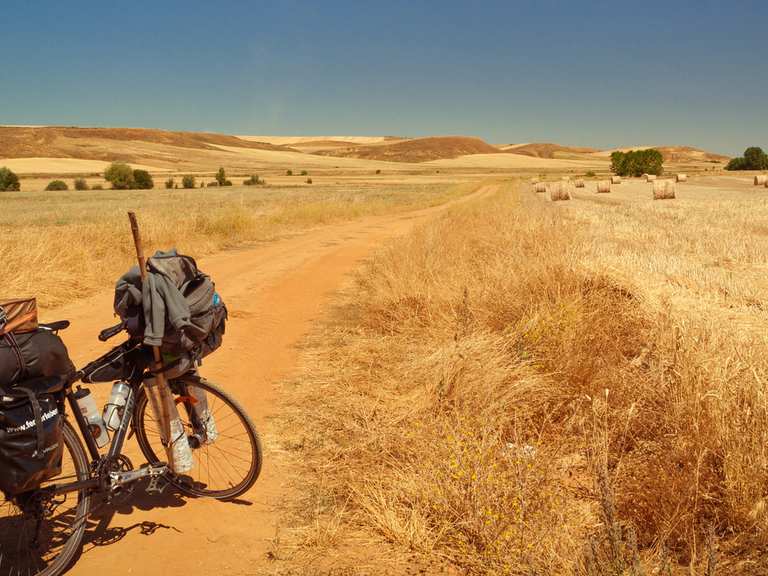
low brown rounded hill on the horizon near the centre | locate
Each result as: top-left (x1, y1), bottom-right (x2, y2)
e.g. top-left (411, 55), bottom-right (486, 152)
top-left (314, 136), bottom-right (499, 162)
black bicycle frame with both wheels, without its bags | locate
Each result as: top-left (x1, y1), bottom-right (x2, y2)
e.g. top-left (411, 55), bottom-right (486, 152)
top-left (0, 320), bottom-right (262, 576)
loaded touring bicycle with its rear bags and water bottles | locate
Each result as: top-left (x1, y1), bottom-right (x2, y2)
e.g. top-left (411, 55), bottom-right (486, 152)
top-left (0, 227), bottom-right (262, 576)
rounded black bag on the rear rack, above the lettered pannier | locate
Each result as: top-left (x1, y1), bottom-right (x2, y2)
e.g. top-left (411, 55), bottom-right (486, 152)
top-left (0, 327), bottom-right (75, 390)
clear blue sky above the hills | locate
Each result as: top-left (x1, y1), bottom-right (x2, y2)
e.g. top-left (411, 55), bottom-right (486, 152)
top-left (0, 0), bottom-right (768, 153)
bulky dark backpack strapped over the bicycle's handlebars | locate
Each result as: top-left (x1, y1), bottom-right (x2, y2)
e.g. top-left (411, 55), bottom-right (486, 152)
top-left (115, 250), bottom-right (227, 361)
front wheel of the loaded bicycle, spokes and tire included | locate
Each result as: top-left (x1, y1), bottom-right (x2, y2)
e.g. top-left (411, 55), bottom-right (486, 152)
top-left (134, 377), bottom-right (262, 500)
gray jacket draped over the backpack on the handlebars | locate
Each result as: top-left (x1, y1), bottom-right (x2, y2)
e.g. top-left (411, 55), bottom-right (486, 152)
top-left (115, 248), bottom-right (192, 346)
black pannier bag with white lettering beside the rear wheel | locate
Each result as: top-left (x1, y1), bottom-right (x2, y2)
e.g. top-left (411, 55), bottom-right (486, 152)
top-left (0, 379), bottom-right (63, 497)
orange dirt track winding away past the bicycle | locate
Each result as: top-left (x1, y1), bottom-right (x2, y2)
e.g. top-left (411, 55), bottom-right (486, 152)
top-left (54, 185), bottom-right (496, 576)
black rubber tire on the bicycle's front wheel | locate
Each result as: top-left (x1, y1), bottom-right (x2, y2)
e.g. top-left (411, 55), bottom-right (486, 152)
top-left (133, 378), bottom-right (263, 500)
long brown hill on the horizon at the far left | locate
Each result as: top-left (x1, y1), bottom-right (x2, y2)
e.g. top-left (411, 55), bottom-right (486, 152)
top-left (0, 126), bottom-right (291, 161)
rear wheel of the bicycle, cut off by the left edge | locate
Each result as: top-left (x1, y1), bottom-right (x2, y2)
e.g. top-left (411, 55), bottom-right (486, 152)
top-left (0, 421), bottom-right (91, 576)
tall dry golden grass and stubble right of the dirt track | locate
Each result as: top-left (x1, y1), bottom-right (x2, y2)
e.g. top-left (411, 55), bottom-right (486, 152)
top-left (276, 179), bottom-right (768, 575)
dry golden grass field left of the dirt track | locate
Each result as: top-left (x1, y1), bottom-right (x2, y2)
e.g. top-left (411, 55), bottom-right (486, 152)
top-left (0, 185), bottom-right (470, 308)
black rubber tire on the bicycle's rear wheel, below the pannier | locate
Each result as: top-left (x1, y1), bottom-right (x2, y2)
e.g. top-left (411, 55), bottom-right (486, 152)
top-left (0, 420), bottom-right (91, 576)
